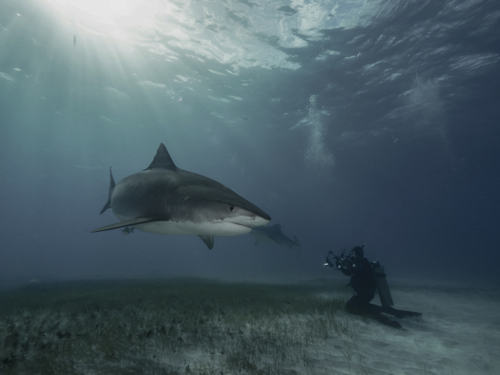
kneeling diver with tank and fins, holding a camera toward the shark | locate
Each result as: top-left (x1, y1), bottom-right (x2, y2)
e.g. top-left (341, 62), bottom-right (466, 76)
top-left (324, 245), bottom-right (422, 328)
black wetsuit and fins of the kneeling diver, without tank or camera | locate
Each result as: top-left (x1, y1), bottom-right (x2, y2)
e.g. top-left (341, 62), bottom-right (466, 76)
top-left (340, 257), bottom-right (421, 328)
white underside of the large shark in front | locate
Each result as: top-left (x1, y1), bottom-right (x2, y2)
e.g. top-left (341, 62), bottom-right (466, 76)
top-left (118, 217), bottom-right (252, 236)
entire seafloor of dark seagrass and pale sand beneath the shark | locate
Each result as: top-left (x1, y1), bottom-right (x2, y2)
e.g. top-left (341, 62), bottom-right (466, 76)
top-left (0, 279), bottom-right (500, 375)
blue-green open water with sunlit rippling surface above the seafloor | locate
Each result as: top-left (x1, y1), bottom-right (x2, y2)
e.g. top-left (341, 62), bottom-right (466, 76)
top-left (0, 0), bottom-right (500, 285)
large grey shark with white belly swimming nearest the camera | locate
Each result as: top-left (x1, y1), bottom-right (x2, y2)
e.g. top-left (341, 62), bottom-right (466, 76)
top-left (91, 143), bottom-right (271, 249)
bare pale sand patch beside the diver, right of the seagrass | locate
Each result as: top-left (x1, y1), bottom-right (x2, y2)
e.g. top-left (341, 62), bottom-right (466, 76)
top-left (317, 287), bottom-right (500, 374)
